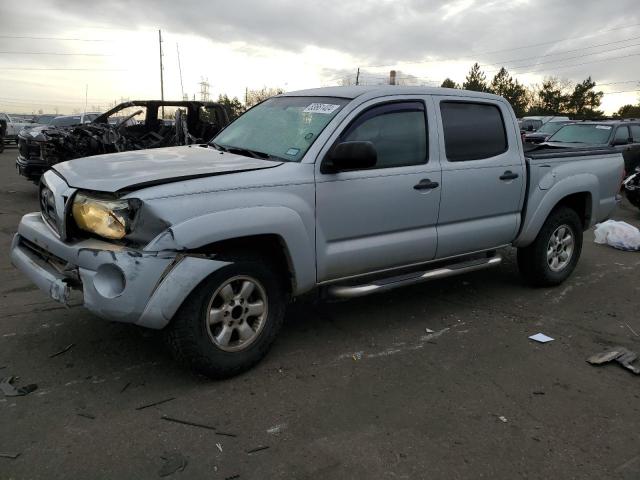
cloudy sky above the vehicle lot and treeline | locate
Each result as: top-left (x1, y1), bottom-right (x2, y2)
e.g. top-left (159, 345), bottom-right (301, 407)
top-left (0, 0), bottom-right (640, 113)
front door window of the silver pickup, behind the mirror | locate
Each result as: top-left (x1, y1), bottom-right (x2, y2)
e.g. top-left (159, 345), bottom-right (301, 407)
top-left (340, 102), bottom-right (428, 168)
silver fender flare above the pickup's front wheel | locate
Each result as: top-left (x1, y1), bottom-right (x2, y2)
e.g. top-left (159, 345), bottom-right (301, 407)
top-left (145, 206), bottom-right (316, 294)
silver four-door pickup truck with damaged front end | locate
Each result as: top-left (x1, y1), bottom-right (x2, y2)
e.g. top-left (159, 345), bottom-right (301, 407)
top-left (11, 86), bottom-right (623, 378)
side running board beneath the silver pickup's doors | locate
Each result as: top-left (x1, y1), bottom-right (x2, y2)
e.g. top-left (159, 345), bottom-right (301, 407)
top-left (328, 255), bottom-right (502, 298)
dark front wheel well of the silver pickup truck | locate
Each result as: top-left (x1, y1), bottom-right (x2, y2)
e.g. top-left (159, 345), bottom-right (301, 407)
top-left (191, 234), bottom-right (295, 293)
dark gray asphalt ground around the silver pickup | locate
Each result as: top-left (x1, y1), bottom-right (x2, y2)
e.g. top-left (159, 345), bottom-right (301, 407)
top-left (0, 147), bottom-right (640, 480)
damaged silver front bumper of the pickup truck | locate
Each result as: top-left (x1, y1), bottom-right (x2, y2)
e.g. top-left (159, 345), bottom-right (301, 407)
top-left (11, 213), bottom-right (226, 329)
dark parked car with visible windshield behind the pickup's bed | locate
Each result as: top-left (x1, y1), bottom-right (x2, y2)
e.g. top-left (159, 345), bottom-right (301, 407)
top-left (541, 120), bottom-right (640, 173)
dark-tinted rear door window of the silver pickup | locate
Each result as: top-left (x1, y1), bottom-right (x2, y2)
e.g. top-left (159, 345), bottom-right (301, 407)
top-left (440, 102), bottom-right (507, 162)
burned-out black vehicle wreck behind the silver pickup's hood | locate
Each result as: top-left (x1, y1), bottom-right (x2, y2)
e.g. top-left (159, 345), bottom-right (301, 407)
top-left (16, 100), bottom-right (229, 183)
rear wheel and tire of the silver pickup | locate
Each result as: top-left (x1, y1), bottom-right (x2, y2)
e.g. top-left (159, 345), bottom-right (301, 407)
top-left (518, 207), bottom-right (582, 287)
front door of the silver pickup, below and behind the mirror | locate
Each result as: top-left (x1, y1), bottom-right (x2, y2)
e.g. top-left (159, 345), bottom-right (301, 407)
top-left (316, 97), bottom-right (441, 282)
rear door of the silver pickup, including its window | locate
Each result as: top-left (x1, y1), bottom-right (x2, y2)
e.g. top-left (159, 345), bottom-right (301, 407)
top-left (434, 96), bottom-right (526, 258)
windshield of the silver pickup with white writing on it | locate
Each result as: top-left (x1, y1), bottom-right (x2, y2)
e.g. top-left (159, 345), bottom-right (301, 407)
top-left (211, 97), bottom-right (349, 162)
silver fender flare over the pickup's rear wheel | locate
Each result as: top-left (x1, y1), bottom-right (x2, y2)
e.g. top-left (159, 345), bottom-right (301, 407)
top-left (513, 173), bottom-right (600, 247)
